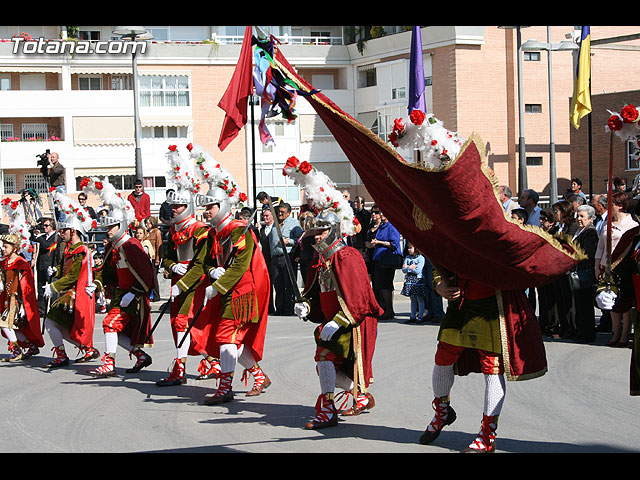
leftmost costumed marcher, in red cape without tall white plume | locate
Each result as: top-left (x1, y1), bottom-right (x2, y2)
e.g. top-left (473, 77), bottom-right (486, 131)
top-left (0, 229), bottom-right (44, 362)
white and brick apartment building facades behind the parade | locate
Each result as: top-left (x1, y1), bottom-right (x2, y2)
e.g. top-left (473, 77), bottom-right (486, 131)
top-left (0, 26), bottom-right (640, 223)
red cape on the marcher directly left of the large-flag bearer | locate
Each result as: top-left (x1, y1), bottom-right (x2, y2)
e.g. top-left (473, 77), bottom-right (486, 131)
top-left (305, 247), bottom-right (384, 387)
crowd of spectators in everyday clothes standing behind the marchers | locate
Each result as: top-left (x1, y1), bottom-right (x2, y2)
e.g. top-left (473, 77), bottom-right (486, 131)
top-left (6, 171), bottom-right (640, 347)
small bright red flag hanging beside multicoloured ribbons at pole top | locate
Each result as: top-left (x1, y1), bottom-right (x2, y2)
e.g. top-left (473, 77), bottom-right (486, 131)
top-left (218, 26), bottom-right (253, 151)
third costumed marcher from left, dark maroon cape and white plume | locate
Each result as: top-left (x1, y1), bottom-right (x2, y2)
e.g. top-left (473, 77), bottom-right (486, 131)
top-left (81, 177), bottom-right (154, 377)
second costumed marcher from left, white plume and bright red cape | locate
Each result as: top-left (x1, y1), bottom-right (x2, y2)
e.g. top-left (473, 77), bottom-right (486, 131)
top-left (44, 191), bottom-right (100, 368)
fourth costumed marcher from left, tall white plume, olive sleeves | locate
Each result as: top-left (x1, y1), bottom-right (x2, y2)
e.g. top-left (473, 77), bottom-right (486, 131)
top-left (156, 144), bottom-right (219, 387)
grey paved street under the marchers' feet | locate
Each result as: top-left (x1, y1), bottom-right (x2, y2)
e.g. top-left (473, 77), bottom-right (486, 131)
top-left (0, 284), bottom-right (640, 453)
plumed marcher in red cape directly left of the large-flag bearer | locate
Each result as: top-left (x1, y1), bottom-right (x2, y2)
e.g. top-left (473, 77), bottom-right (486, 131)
top-left (283, 157), bottom-right (383, 430)
